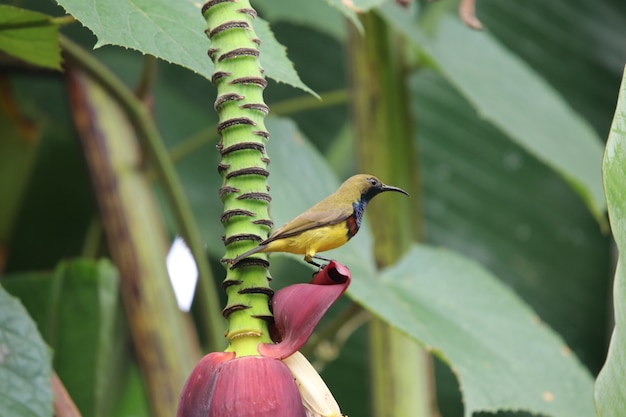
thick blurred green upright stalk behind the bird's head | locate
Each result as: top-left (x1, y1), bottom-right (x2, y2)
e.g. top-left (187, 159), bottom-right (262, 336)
top-left (347, 12), bottom-right (438, 417)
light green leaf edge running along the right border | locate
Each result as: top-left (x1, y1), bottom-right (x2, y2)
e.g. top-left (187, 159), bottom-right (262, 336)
top-left (595, 66), bottom-right (626, 417)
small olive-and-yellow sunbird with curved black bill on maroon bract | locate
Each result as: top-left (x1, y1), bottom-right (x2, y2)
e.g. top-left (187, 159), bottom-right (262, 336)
top-left (230, 174), bottom-right (409, 267)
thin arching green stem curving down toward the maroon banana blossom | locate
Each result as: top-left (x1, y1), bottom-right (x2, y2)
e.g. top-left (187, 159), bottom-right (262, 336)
top-left (60, 36), bottom-right (223, 350)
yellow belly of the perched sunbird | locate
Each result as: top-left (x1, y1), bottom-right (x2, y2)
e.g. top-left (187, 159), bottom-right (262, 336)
top-left (263, 223), bottom-right (348, 257)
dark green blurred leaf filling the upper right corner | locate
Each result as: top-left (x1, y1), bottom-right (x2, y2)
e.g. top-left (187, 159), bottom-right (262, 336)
top-left (477, 0), bottom-right (626, 135)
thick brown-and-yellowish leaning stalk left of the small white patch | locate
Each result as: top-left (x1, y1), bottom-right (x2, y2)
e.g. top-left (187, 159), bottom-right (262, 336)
top-left (66, 66), bottom-right (200, 417)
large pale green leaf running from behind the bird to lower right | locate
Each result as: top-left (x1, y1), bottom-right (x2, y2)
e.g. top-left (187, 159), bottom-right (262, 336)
top-left (267, 118), bottom-right (593, 416)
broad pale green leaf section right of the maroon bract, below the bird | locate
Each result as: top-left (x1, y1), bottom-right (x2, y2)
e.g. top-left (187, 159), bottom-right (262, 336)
top-left (370, 246), bottom-right (594, 417)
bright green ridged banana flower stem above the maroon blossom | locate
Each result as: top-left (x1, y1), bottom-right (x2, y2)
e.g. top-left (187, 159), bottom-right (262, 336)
top-left (202, 0), bottom-right (272, 356)
